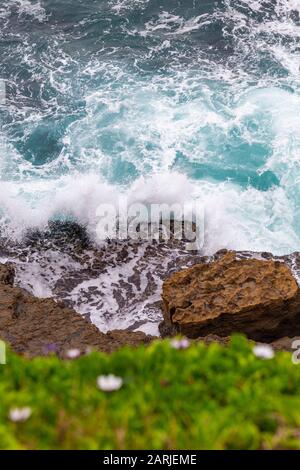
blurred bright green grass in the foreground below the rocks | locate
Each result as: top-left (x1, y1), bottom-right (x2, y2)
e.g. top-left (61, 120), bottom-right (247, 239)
top-left (0, 336), bottom-right (300, 450)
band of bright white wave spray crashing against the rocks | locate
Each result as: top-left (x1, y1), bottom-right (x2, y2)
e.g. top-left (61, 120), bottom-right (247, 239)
top-left (0, 166), bottom-right (299, 254)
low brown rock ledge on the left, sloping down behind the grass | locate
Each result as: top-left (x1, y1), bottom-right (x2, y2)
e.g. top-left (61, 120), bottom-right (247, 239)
top-left (0, 265), bottom-right (151, 357)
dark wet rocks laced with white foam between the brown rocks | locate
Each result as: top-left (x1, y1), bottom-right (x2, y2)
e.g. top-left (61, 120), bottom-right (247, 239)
top-left (0, 222), bottom-right (203, 335)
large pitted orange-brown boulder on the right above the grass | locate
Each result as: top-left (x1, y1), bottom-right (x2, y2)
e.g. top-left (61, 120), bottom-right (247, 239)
top-left (161, 252), bottom-right (300, 341)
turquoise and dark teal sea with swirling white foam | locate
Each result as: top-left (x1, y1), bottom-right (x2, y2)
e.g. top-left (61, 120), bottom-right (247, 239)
top-left (0, 0), bottom-right (300, 334)
